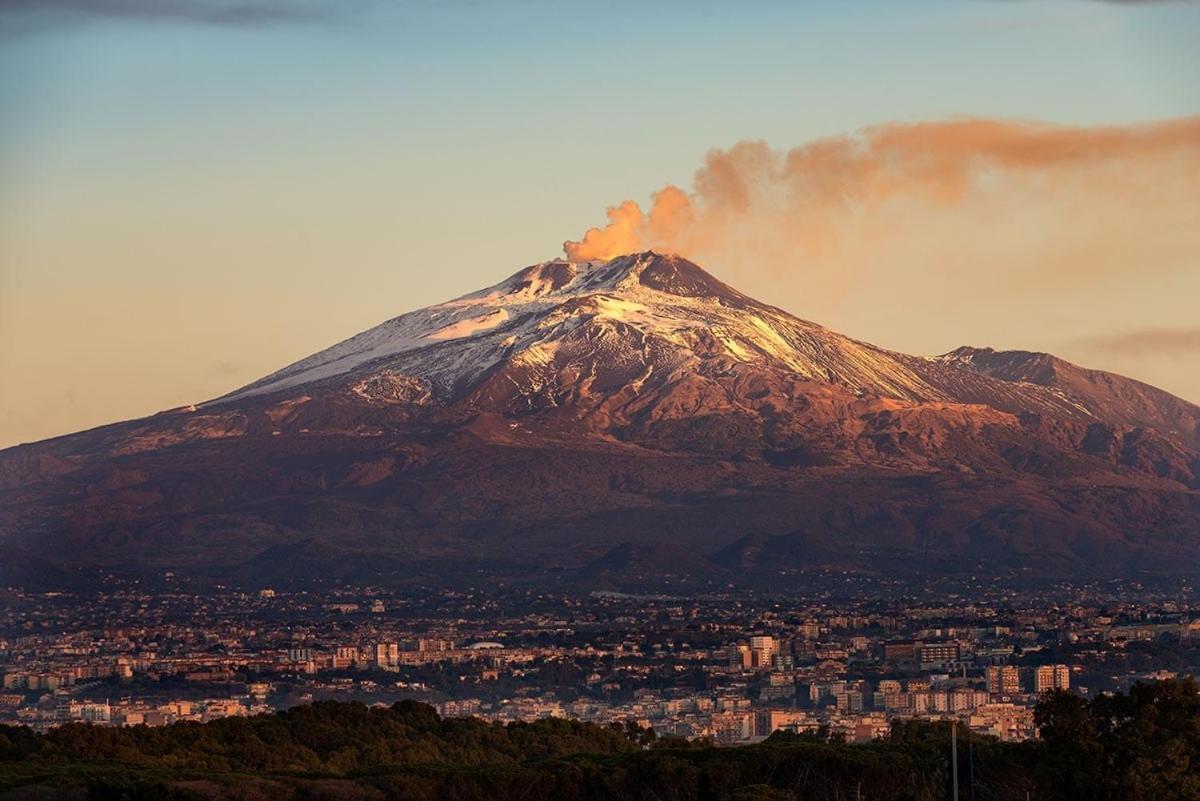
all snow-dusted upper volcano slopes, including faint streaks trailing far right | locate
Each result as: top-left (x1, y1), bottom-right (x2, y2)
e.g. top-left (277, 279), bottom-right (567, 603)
top-left (220, 252), bottom-right (1104, 429)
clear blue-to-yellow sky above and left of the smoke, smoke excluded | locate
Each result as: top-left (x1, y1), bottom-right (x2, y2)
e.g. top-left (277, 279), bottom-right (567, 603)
top-left (0, 0), bottom-right (1200, 445)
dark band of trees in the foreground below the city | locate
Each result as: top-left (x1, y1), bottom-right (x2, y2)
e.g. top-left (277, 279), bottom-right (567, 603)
top-left (0, 679), bottom-right (1200, 801)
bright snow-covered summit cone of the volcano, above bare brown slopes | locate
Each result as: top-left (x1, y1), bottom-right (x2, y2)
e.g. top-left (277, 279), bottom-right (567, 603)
top-left (223, 253), bottom-right (944, 401)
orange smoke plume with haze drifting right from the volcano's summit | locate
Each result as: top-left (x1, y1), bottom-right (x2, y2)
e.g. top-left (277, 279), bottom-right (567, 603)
top-left (564, 116), bottom-right (1200, 301)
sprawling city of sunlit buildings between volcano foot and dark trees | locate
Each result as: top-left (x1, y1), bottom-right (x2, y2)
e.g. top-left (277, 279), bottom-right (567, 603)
top-left (0, 579), bottom-right (1200, 745)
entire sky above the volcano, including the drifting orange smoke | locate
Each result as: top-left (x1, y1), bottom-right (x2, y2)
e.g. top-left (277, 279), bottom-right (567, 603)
top-left (0, 0), bottom-right (1200, 447)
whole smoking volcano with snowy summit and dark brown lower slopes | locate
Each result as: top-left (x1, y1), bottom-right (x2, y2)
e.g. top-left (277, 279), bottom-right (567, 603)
top-left (0, 252), bottom-right (1200, 588)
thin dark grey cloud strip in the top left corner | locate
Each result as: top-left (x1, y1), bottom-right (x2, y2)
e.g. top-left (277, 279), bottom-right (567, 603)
top-left (0, 0), bottom-right (358, 28)
